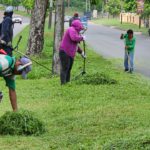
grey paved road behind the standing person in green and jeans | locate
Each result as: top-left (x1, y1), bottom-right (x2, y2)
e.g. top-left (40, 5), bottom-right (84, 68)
top-left (86, 23), bottom-right (150, 77)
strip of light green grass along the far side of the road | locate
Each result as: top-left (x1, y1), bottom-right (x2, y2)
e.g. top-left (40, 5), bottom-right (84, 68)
top-left (93, 18), bottom-right (148, 35)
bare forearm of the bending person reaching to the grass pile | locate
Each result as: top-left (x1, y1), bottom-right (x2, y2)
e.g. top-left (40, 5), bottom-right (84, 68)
top-left (9, 88), bottom-right (18, 111)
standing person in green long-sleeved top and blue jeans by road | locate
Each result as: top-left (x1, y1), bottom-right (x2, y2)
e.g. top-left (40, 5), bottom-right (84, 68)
top-left (120, 29), bottom-right (136, 73)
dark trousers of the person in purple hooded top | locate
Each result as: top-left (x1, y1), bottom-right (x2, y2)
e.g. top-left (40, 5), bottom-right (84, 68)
top-left (59, 51), bottom-right (74, 84)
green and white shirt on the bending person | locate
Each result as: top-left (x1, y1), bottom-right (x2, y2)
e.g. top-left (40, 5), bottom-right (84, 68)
top-left (0, 54), bottom-right (16, 90)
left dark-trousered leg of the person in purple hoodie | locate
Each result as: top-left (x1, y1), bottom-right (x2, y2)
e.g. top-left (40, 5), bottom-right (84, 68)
top-left (59, 51), bottom-right (69, 84)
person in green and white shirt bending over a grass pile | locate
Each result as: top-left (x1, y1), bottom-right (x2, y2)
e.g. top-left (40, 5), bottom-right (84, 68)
top-left (0, 54), bottom-right (32, 111)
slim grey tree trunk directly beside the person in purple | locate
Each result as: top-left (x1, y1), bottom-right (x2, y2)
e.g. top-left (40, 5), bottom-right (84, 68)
top-left (52, 0), bottom-right (64, 74)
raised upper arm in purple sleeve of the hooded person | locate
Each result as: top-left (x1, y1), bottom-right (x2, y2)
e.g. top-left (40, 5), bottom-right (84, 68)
top-left (69, 29), bottom-right (83, 42)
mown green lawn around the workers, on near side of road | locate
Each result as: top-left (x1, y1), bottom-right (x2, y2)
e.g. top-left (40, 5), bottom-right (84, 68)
top-left (0, 22), bottom-right (150, 150)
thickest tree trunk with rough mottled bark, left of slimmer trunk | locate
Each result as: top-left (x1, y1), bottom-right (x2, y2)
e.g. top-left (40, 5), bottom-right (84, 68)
top-left (27, 0), bottom-right (48, 55)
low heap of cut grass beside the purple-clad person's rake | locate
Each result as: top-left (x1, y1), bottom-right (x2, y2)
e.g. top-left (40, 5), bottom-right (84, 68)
top-left (77, 73), bottom-right (117, 85)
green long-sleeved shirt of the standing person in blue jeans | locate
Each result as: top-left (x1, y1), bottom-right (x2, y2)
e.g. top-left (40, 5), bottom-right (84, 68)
top-left (124, 34), bottom-right (136, 52)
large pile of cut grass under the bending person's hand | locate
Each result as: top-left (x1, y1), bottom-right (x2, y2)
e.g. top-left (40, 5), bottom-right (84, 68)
top-left (0, 110), bottom-right (46, 135)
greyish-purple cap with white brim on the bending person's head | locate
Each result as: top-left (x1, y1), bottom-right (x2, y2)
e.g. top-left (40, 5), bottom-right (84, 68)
top-left (20, 57), bottom-right (32, 79)
